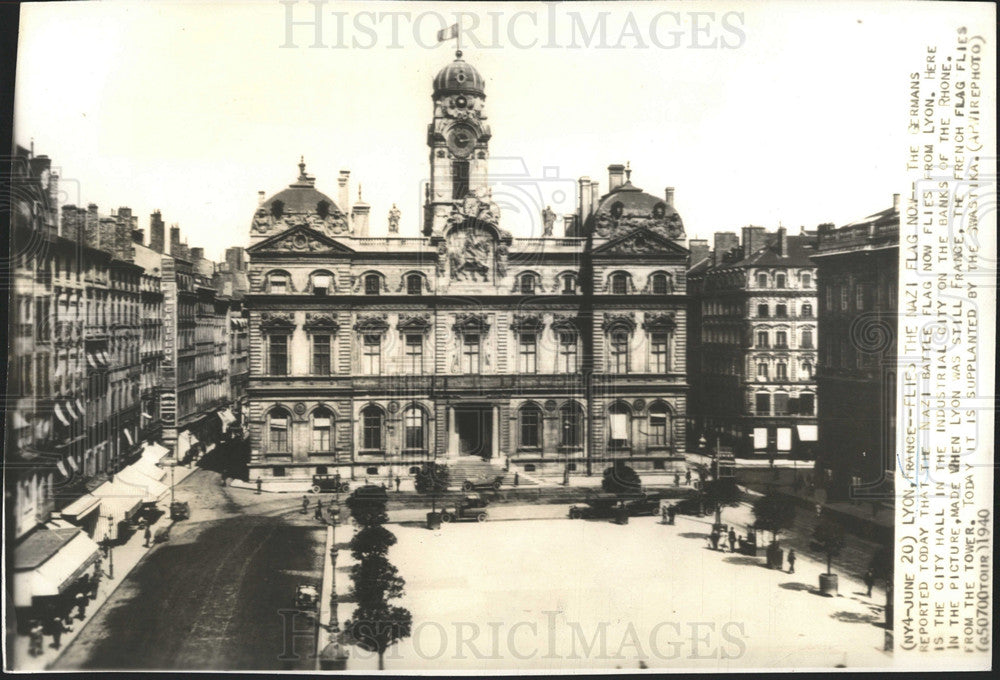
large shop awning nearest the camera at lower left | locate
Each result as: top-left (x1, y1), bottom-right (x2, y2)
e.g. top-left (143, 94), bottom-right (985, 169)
top-left (13, 529), bottom-right (99, 607)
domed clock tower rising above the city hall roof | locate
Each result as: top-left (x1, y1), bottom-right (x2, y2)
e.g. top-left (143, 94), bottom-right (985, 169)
top-left (423, 50), bottom-right (490, 236)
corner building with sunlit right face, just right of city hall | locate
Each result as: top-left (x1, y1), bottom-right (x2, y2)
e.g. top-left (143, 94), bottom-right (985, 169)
top-left (688, 227), bottom-right (817, 459)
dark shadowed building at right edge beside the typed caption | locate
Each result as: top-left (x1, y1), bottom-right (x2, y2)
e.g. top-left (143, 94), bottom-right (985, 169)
top-left (812, 194), bottom-right (899, 499)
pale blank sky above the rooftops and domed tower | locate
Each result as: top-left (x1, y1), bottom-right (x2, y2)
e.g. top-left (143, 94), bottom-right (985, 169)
top-left (15, 0), bottom-right (985, 259)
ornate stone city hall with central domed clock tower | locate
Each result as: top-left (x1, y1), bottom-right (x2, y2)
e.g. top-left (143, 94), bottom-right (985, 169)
top-left (246, 53), bottom-right (688, 480)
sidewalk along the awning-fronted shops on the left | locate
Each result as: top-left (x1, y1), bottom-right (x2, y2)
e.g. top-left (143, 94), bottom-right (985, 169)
top-left (12, 465), bottom-right (197, 671)
